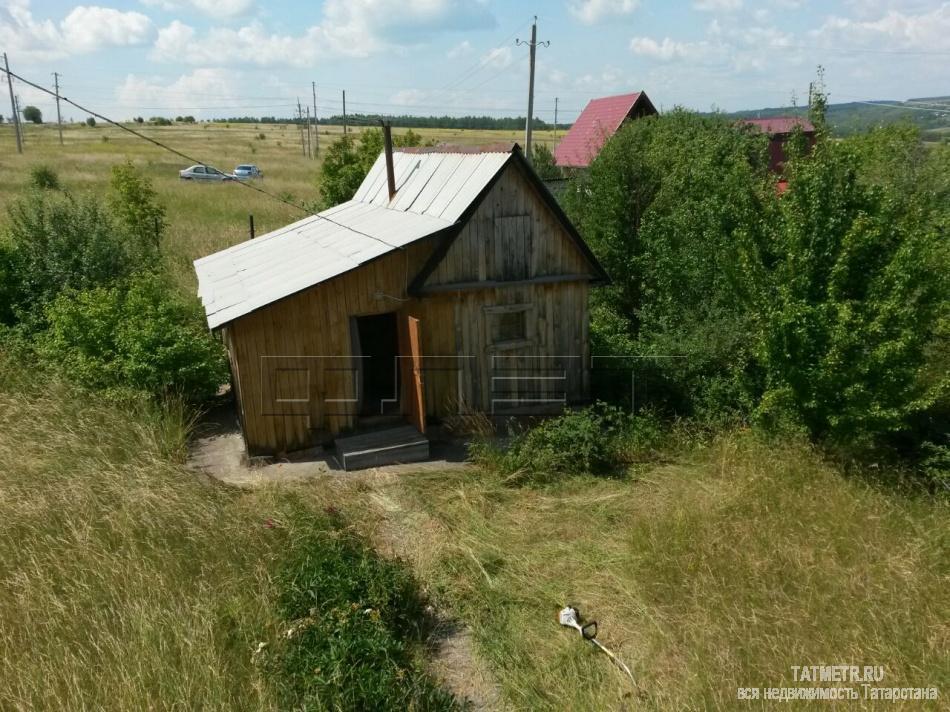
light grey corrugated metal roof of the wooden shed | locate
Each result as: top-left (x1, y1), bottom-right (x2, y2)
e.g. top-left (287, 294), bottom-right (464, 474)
top-left (194, 151), bottom-right (511, 329)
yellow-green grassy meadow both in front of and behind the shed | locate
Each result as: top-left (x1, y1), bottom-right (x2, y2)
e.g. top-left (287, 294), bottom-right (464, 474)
top-left (0, 119), bottom-right (950, 710)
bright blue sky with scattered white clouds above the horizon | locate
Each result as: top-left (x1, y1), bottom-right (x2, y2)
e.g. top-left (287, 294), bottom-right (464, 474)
top-left (0, 0), bottom-right (950, 122)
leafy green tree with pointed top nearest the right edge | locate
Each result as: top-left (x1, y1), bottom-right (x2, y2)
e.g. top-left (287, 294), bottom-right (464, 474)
top-left (759, 140), bottom-right (950, 445)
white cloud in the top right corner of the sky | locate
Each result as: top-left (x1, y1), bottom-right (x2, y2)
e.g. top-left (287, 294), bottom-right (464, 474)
top-left (811, 3), bottom-right (950, 52)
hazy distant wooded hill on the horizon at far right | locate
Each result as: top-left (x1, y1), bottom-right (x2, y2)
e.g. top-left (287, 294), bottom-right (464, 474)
top-left (725, 96), bottom-right (950, 141)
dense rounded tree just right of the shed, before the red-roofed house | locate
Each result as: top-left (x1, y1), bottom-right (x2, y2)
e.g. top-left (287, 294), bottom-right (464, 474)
top-left (564, 111), bottom-right (774, 416)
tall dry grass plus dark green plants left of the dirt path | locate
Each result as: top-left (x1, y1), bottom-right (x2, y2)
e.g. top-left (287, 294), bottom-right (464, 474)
top-left (0, 353), bottom-right (454, 710)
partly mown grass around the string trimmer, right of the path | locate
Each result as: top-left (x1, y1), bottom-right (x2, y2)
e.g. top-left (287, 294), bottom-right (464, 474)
top-left (388, 435), bottom-right (950, 710)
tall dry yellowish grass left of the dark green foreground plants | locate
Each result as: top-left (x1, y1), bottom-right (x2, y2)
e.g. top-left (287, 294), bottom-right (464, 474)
top-left (0, 362), bottom-right (292, 710)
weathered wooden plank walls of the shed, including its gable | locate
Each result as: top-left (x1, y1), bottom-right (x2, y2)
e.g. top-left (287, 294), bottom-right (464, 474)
top-left (223, 163), bottom-right (593, 454)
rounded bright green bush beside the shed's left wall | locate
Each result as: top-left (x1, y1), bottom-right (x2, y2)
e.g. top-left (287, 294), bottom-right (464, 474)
top-left (37, 273), bottom-right (228, 401)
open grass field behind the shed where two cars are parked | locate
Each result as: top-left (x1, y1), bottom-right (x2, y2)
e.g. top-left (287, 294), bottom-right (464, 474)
top-left (0, 123), bottom-right (553, 292)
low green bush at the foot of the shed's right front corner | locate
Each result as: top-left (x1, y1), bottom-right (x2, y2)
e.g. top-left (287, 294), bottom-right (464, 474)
top-left (470, 403), bottom-right (662, 483)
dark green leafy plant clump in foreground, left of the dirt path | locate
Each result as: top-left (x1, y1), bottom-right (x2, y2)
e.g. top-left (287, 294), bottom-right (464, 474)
top-left (263, 512), bottom-right (458, 710)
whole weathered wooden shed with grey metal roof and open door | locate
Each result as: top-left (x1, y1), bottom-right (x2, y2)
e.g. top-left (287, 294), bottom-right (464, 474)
top-left (195, 140), bottom-right (605, 464)
